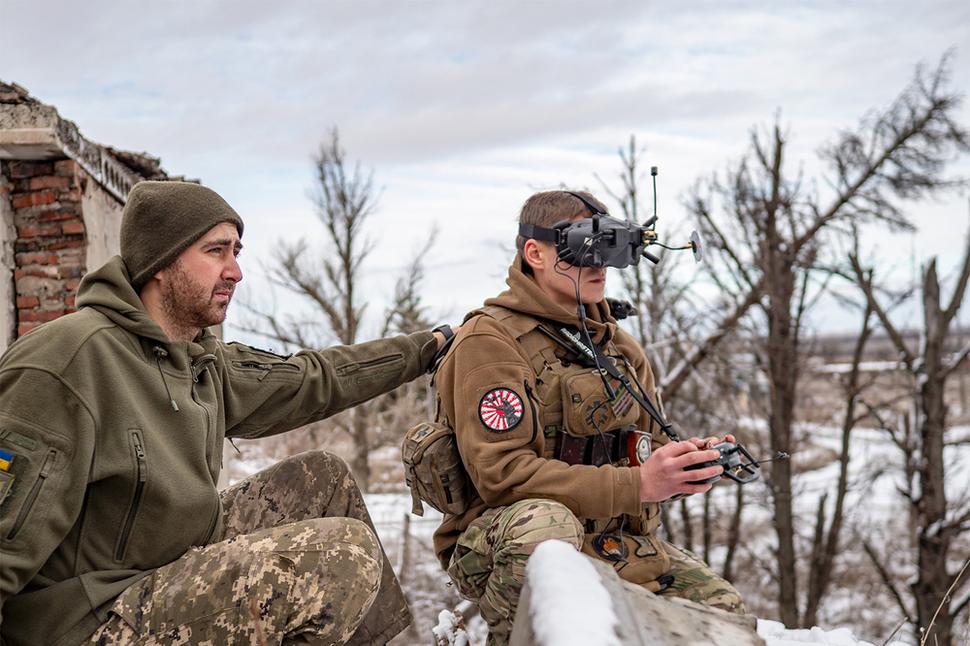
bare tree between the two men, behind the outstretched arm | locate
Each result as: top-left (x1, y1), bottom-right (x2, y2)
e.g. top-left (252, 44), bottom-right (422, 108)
top-left (243, 128), bottom-right (433, 491)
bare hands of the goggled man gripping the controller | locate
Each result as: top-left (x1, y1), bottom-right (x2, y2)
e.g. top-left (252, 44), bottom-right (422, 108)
top-left (639, 438), bottom-right (724, 502)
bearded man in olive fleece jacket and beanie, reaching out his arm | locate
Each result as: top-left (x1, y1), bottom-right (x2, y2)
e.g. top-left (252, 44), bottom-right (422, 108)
top-left (0, 182), bottom-right (444, 646)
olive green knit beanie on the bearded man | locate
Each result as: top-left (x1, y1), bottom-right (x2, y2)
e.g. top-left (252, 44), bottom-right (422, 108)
top-left (121, 182), bottom-right (243, 289)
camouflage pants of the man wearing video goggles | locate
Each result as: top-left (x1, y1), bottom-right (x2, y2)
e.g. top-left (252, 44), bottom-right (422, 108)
top-left (448, 499), bottom-right (745, 646)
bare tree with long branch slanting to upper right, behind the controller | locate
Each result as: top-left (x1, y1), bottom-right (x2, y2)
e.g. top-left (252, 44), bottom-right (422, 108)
top-left (680, 57), bottom-right (968, 625)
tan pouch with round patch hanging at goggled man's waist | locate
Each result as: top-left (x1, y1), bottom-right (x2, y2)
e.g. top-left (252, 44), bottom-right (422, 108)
top-left (582, 532), bottom-right (670, 589)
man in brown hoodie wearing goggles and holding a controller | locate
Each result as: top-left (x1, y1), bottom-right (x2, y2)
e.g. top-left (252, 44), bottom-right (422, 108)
top-left (435, 191), bottom-right (744, 646)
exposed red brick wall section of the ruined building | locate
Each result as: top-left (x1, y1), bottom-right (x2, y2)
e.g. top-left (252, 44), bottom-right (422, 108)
top-left (0, 159), bottom-right (87, 336)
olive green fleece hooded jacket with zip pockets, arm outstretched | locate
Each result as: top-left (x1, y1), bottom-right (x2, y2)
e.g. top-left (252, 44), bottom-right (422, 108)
top-left (0, 257), bottom-right (436, 646)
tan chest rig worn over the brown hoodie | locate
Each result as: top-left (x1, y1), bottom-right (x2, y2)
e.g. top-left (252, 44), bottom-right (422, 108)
top-left (480, 305), bottom-right (650, 466)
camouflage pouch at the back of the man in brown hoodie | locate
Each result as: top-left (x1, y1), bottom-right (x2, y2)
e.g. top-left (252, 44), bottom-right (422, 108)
top-left (401, 422), bottom-right (470, 516)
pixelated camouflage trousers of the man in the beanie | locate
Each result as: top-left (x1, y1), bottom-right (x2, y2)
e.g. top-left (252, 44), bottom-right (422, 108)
top-left (91, 451), bottom-right (411, 646)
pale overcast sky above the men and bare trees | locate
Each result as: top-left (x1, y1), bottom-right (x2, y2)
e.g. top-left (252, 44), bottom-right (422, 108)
top-left (0, 0), bottom-right (970, 344)
